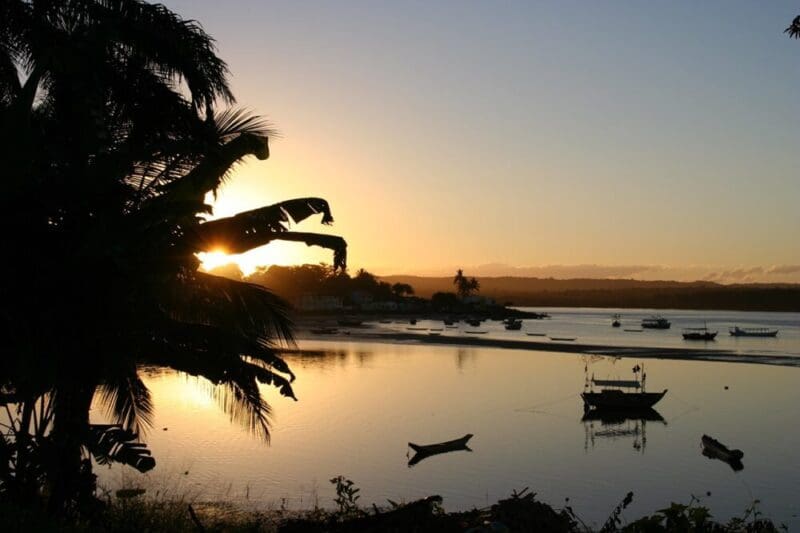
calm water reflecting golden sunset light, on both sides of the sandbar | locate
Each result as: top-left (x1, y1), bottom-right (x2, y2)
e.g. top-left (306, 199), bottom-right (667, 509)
top-left (95, 310), bottom-right (800, 529)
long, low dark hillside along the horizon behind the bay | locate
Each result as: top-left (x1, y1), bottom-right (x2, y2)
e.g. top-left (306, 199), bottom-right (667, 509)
top-left (380, 276), bottom-right (800, 312)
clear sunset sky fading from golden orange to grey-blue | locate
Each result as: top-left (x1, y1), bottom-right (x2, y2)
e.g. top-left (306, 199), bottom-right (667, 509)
top-left (165, 0), bottom-right (800, 281)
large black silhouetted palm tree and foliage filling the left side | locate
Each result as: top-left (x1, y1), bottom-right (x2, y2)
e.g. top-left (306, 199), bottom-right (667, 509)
top-left (0, 0), bottom-right (346, 515)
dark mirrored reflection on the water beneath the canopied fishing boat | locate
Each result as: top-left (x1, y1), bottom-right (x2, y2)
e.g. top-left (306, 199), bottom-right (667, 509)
top-left (581, 408), bottom-right (667, 453)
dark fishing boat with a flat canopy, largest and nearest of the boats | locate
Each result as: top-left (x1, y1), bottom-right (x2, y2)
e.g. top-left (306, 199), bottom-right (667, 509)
top-left (581, 365), bottom-right (667, 411)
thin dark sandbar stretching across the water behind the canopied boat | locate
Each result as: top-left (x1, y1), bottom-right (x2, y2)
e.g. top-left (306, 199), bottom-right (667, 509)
top-left (290, 326), bottom-right (800, 368)
